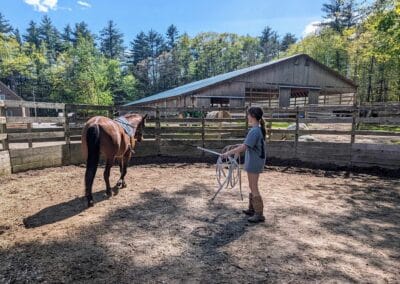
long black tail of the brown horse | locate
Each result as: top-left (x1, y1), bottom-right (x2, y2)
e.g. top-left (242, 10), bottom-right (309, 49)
top-left (85, 124), bottom-right (100, 206)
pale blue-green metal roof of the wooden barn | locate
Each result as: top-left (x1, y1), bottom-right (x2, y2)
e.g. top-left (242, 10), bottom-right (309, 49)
top-left (125, 54), bottom-right (354, 106)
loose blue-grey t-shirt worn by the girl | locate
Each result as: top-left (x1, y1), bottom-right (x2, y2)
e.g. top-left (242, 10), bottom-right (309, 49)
top-left (244, 126), bottom-right (266, 173)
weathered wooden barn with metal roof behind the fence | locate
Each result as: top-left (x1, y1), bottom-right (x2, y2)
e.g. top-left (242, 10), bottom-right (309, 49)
top-left (126, 54), bottom-right (357, 107)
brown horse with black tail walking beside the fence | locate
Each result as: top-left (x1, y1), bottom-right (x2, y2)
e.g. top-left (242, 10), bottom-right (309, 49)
top-left (82, 114), bottom-right (147, 207)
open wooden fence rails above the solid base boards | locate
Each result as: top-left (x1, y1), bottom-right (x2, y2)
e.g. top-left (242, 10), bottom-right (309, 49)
top-left (0, 101), bottom-right (400, 152)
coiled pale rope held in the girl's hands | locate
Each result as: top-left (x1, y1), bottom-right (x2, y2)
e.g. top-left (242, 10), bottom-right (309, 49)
top-left (197, 145), bottom-right (243, 201)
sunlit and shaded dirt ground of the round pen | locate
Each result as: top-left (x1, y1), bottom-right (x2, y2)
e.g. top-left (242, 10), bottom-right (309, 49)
top-left (0, 164), bottom-right (400, 283)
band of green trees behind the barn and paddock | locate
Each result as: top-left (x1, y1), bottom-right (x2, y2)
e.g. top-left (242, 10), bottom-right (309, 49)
top-left (0, 0), bottom-right (400, 105)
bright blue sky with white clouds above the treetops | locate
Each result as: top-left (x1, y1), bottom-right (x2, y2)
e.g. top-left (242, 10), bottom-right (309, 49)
top-left (0, 0), bottom-right (326, 44)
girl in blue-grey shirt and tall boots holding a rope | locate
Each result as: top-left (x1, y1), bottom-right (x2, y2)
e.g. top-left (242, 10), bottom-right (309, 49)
top-left (222, 107), bottom-right (267, 223)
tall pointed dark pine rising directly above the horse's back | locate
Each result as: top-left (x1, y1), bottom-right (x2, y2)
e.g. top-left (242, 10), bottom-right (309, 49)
top-left (100, 21), bottom-right (124, 59)
